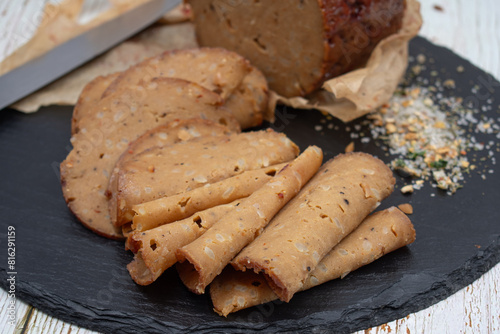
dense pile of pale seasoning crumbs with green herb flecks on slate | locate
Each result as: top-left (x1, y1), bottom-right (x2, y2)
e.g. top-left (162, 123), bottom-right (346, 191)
top-left (369, 80), bottom-right (500, 195)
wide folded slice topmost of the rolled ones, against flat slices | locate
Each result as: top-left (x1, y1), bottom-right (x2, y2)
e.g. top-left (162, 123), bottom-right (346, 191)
top-left (110, 130), bottom-right (298, 226)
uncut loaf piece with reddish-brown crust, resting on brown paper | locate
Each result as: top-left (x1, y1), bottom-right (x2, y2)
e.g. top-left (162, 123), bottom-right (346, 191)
top-left (188, 0), bottom-right (405, 97)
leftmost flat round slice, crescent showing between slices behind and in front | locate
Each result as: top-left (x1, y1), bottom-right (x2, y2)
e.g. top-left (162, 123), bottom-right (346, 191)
top-left (60, 78), bottom-right (242, 239)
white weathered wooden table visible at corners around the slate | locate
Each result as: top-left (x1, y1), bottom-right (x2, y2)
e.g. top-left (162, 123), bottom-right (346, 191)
top-left (0, 0), bottom-right (500, 334)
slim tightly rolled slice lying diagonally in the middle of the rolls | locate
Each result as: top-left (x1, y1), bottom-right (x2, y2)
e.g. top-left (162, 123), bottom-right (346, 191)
top-left (177, 146), bottom-right (323, 294)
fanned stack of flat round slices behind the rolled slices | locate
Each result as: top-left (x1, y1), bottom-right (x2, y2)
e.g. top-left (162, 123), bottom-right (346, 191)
top-left (61, 48), bottom-right (272, 239)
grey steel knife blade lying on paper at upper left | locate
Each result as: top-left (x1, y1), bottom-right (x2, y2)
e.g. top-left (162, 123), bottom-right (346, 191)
top-left (0, 0), bottom-right (181, 110)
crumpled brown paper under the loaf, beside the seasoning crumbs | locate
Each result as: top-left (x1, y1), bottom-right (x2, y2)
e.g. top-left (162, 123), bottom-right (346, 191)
top-left (270, 0), bottom-right (422, 122)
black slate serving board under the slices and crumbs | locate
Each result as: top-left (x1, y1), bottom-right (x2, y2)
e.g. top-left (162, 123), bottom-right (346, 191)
top-left (0, 38), bottom-right (500, 333)
